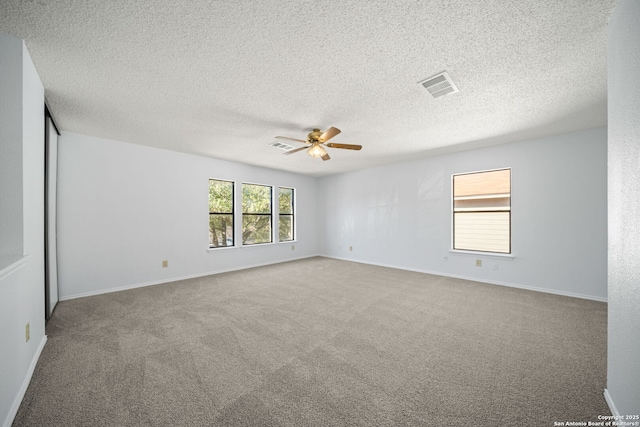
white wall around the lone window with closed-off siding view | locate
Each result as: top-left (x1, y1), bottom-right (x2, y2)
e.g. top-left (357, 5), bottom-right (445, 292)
top-left (319, 128), bottom-right (607, 300)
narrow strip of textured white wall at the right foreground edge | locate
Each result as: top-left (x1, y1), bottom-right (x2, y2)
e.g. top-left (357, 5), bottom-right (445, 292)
top-left (605, 0), bottom-right (640, 421)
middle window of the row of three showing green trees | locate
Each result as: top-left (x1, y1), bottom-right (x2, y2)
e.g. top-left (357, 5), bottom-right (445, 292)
top-left (242, 184), bottom-right (273, 245)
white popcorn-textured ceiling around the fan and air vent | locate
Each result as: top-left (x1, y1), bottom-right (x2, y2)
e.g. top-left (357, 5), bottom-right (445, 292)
top-left (0, 0), bottom-right (617, 176)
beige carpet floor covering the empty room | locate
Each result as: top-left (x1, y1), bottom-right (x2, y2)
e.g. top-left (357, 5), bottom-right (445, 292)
top-left (14, 257), bottom-right (609, 426)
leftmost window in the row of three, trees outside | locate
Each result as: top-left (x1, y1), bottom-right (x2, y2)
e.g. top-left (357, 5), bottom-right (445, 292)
top-left (209, 179), bottom-right (234, 248)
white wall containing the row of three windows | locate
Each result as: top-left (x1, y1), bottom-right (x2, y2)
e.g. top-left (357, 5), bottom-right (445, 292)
top-left (58, 133), bottom-right (318, 299)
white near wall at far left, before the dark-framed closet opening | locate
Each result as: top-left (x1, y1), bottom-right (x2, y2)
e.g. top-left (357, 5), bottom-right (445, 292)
top-left (0, 34), bottom-right (46, 426)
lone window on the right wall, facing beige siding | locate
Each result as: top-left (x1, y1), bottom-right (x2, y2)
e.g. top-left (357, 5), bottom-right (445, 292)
top-left (453, 169), bottom-right (511, 254)
